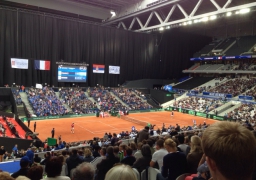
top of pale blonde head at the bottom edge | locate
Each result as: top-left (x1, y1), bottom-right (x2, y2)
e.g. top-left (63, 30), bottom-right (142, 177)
top-left (105, 165), bottom-right (138, 180)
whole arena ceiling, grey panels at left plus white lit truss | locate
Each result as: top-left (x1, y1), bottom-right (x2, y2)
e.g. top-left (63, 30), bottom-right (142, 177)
top-left (3, 0), bottom-right (256, 32)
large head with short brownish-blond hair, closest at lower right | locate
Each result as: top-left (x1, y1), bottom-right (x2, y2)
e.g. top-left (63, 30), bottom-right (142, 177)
top-left (202, 121), bottom-right (256, 180)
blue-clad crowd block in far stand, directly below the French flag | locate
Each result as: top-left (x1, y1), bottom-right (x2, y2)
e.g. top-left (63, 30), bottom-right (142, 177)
top-left (26, 86), bottom-right (68, 117)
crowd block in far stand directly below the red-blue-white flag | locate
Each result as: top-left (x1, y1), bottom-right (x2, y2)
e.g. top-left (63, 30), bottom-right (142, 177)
top-left (88, 86), bottom-right (126, 111)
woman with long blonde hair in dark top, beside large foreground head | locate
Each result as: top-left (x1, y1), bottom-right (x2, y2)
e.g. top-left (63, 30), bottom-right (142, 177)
top-left (187, 136), bottom-right (203, 174)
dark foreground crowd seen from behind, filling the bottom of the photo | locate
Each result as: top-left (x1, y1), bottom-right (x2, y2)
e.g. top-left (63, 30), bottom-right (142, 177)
top-left (0, 116), bottom-right (256, 180)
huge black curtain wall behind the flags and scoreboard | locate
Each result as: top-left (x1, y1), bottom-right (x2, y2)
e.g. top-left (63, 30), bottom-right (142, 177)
top-left (0, 9), bottom-right (208, 87)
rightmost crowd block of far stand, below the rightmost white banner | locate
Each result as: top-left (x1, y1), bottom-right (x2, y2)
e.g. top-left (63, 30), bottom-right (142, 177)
top-left (112, 88), bottom-right (153, 110)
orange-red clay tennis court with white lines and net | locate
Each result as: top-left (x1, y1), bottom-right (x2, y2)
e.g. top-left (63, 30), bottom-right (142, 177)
top-left (30, 111), bottom-right (216, 142)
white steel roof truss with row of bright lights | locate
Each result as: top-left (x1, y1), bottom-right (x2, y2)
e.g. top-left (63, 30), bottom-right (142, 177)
top-left (103, 0), bottom-right (256, 32)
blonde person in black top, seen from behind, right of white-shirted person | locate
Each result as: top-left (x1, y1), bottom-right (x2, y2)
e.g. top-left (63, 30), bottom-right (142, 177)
top-left (157, 138), bottom-right (187, 180)
